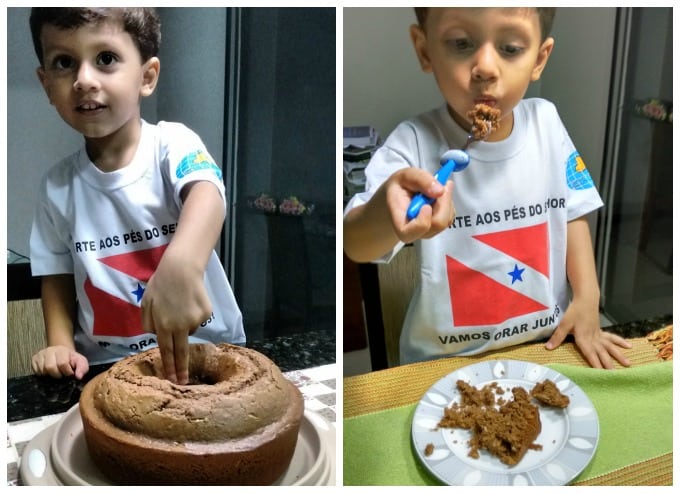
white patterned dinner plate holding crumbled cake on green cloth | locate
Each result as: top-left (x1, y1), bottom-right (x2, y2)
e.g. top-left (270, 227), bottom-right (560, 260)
top-left (411, 360), bottom-right (600, 485)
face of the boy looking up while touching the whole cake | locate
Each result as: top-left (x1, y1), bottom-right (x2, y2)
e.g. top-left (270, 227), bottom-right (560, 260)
top-left (37, 22), bottom-right (160, 138)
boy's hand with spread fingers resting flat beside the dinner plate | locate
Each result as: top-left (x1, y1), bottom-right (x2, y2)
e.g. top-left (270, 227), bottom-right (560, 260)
top-left (545, 301), bottom-right (632, 369)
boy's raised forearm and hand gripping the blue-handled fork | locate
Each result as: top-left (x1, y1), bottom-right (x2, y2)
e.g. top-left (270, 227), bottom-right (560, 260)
top-left (343, 168), bottom-right (455, 262)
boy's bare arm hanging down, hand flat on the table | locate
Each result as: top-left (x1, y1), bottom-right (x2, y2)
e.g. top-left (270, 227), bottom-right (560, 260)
top-left (546, 217), bottom-right (631, 369)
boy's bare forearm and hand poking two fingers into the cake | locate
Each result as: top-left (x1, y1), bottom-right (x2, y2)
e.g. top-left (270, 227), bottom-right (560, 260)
top-left (142, 181), bottom-right (224, 384)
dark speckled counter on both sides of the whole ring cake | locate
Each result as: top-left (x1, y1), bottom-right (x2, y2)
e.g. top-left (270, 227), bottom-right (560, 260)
top-left (7, 331), bottom-right (335, 422)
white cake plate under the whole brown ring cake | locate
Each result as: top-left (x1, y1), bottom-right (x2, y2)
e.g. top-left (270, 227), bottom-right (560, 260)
top-left (19, 405), bottom-right (335, 485)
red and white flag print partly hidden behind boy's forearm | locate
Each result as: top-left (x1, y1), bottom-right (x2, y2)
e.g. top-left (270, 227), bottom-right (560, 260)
top-left (85, 245), bottom-right (167, 337)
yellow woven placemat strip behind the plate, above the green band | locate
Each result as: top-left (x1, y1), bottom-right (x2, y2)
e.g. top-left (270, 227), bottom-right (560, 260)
top-left (343, 337), bottom-right (660, 418)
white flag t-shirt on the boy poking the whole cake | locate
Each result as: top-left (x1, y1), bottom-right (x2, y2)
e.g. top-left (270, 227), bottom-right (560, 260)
top-left (31, 117), bottom-right (245, 364)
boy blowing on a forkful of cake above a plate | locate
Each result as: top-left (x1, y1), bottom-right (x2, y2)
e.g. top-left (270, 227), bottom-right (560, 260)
top-left (344, 8), bottom-right (630, 368)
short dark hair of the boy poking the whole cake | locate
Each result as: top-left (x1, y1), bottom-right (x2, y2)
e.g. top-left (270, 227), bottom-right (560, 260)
top-left (29, 7), bottom-right (161, 65)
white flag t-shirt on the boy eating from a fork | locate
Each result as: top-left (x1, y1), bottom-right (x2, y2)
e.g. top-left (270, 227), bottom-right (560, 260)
top-left (345, 99), bottom-right (603, 363)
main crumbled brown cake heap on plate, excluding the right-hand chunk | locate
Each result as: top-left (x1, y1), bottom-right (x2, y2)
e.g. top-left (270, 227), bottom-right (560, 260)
top-left (438, 380), bottom-right (542, 465)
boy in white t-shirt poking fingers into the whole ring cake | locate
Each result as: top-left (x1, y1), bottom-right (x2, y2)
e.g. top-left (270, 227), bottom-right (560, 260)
top-left (30, 8), bottom-right (245, 384)
